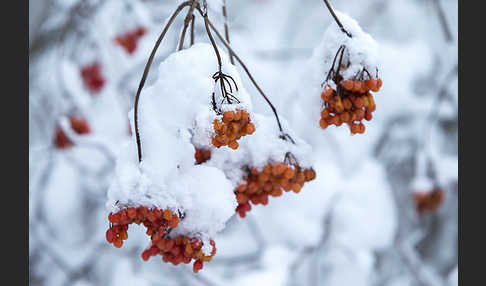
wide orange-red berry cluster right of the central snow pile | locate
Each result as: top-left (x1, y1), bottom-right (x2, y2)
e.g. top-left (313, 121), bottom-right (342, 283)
top-left (235, 162), bottom-right (316, 218)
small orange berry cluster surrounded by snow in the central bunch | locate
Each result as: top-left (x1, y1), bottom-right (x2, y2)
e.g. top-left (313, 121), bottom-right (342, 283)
top-left (212, 109), bottom-right (255, 150)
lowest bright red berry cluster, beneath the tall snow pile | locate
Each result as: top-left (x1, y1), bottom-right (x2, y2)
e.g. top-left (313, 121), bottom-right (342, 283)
top-left (106, 206), bottom-right (216, 273)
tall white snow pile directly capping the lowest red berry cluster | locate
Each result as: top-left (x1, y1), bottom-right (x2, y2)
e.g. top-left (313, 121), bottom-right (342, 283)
top-left (108, 44), bottom-right (241, 239)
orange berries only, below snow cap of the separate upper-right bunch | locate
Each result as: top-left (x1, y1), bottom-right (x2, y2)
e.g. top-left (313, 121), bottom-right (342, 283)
top-left (319, 78), bottom-right (382, 134)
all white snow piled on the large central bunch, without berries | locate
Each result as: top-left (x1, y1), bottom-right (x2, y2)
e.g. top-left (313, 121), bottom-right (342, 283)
top-left (107, 44), bottom-right (311, 252)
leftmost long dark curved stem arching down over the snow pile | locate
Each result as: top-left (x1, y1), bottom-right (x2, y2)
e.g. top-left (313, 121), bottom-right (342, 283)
top-left (133, 1), bottom-right (193, 162)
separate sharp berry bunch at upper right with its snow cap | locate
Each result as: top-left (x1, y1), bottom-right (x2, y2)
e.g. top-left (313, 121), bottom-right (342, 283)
top-left (313, 13), bottom-right (382, 134)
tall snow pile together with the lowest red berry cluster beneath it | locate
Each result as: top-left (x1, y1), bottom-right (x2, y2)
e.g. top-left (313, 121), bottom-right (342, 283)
top-left (107, 44), bottom-right (247, 271)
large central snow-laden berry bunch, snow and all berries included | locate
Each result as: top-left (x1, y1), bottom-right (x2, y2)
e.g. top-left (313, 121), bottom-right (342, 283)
top-left (107, 44), bottom-right (316, 272)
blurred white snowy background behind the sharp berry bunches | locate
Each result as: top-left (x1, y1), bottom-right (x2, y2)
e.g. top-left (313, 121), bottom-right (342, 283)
top-left (29, 0), bottom-right (458, 286)
